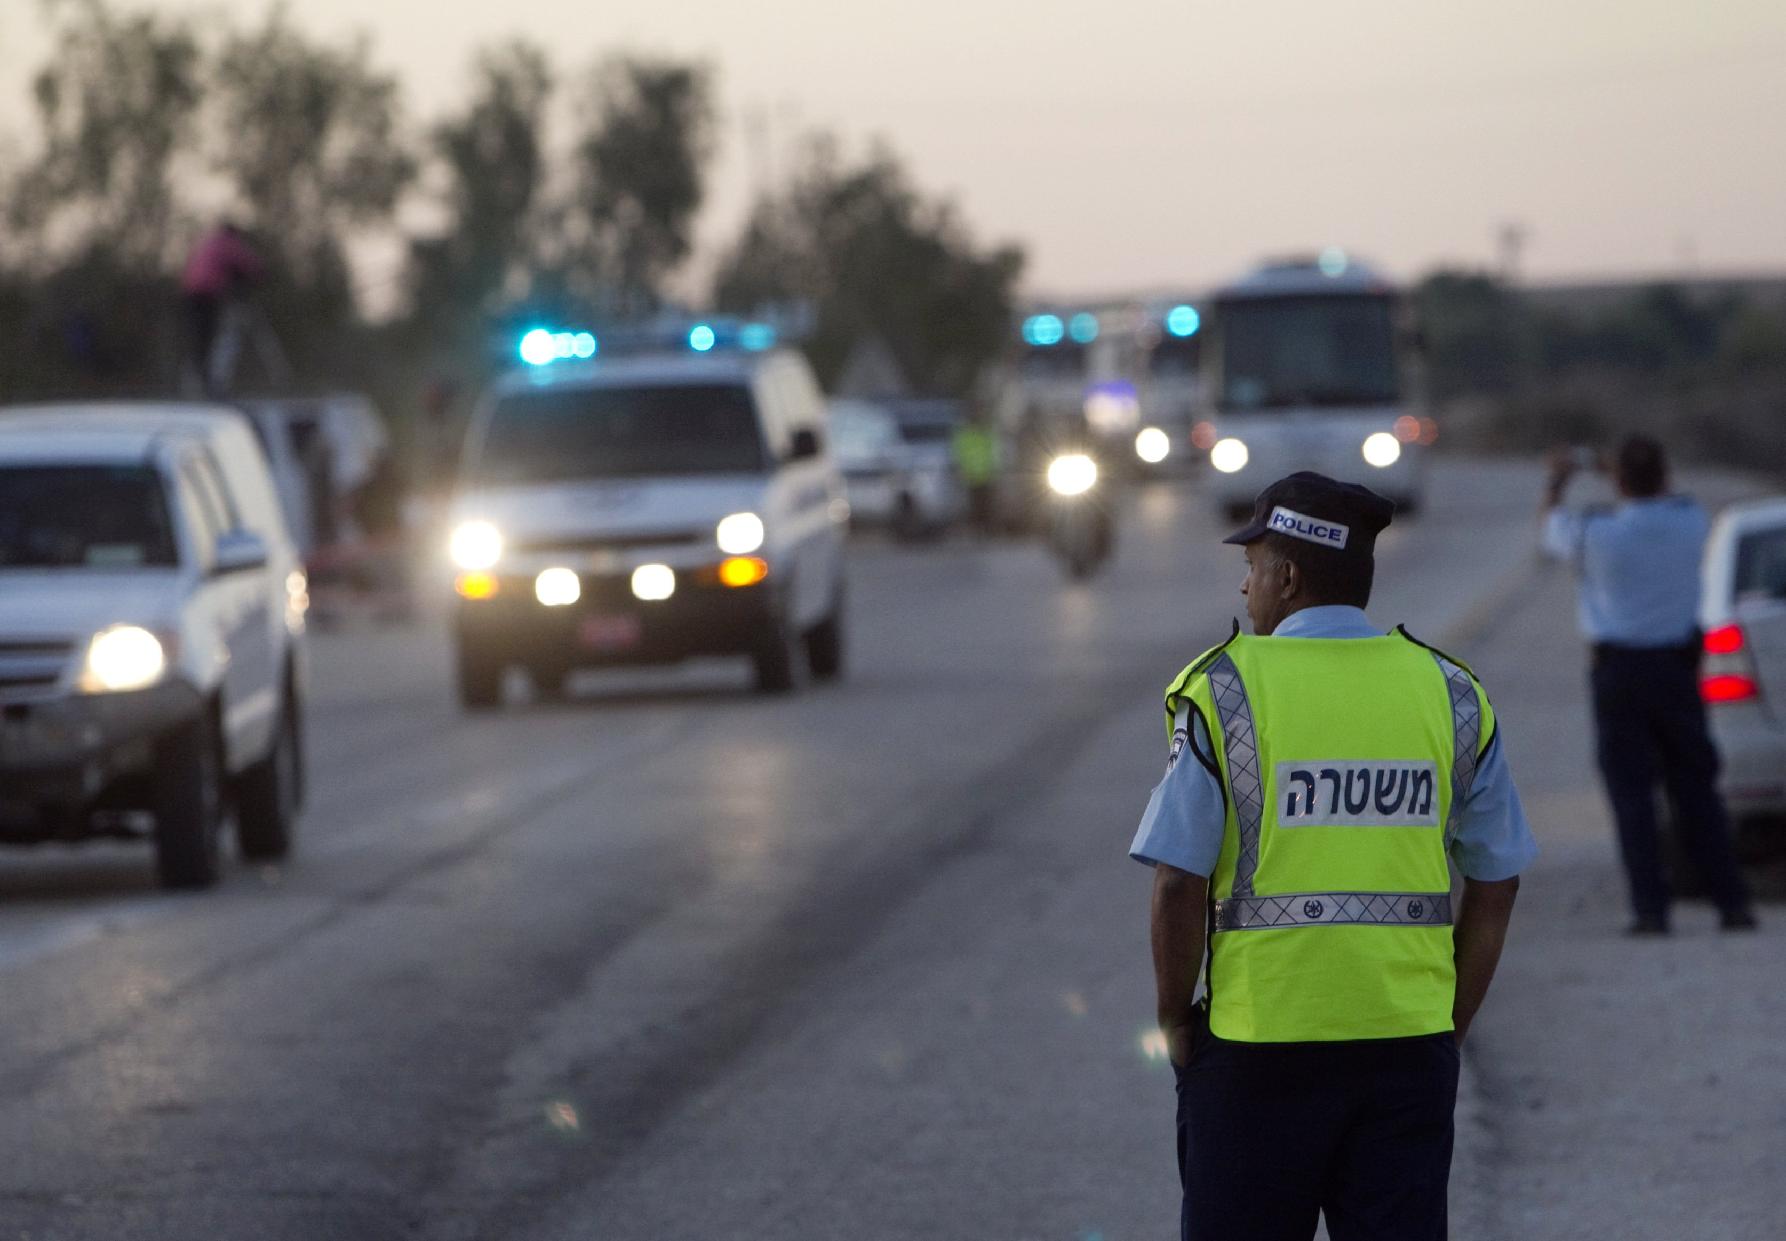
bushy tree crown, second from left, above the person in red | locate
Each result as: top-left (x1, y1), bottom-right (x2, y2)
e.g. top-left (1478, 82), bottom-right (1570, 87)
top-left (214, 7), bottom-right (416, 296)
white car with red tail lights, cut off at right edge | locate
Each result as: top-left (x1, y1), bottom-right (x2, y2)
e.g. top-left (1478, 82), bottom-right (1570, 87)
top-left (1700, 498), bottom-right (1786, 839)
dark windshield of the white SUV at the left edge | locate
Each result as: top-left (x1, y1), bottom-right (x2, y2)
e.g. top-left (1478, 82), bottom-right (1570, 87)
top-left (0, 466), bottom-right (179, 570)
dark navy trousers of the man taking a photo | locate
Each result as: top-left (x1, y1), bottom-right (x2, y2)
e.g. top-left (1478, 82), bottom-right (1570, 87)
top-left (1593, 645), bottom-right (1748, 923)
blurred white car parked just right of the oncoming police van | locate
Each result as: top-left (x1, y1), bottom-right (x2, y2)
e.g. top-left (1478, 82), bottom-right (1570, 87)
top-left (830, 400), bottom-right (961, 539)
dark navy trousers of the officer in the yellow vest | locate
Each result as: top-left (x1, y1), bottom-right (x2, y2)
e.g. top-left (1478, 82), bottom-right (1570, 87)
top-left (1177, 1034), bottom-right (1457, 1241)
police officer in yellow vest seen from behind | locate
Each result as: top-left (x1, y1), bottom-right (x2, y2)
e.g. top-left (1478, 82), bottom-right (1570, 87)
top-left (1131, 473), bottom-right (1538, 1241)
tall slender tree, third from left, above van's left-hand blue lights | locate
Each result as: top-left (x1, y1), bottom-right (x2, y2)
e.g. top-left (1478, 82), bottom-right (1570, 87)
top-left (409, 41), bottom-right (552, 332)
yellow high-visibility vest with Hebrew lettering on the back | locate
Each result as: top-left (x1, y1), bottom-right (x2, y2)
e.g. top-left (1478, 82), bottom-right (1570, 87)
top-left (1166, 630), bottom-right (1495, 1043)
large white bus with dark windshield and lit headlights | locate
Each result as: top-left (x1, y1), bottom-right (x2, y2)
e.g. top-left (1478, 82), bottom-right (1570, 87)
top-left (1198, 250), bottom-right (1436, 518)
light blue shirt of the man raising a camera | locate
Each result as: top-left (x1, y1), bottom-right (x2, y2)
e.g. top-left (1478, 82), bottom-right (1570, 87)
top-left (1543, 496), bottom-right (1711, 646)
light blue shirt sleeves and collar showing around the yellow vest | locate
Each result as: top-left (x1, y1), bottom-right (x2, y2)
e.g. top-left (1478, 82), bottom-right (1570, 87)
top-left (1129, 607), bottom-right (1538, 882)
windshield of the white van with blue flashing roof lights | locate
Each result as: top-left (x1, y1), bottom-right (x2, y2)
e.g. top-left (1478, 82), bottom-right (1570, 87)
top-left (473, 384), bottom-right (768, 486)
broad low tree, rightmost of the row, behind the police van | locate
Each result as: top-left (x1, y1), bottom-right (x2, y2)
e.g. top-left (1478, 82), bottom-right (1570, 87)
top-left (714, 139), bottom-right (1023, 395)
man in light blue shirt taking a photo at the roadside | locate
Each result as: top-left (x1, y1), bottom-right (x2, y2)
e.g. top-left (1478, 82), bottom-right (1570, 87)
top-left (1543, 436), bottom-right (1756, 936)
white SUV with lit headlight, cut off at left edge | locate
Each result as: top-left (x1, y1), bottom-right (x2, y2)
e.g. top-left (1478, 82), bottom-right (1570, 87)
top-left (0, 404), bottom-right (305, 887)
